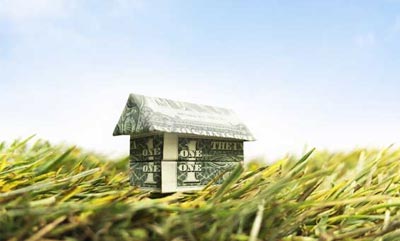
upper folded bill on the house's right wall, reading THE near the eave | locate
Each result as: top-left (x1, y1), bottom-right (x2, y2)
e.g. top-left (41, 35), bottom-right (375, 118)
top-left (178, 138), bottom-right (243, 162)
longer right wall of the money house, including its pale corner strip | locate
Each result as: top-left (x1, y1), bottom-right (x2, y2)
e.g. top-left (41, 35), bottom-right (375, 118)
top-left (161, 134), bottom-right (243, 192)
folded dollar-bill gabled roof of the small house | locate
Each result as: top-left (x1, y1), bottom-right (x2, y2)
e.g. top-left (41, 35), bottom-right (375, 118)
top-left (113, 94), bottom-right (254, 141)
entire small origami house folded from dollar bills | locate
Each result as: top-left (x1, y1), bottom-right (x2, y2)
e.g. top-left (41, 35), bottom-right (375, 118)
top-left (114, 94), bottom-right (254, 193)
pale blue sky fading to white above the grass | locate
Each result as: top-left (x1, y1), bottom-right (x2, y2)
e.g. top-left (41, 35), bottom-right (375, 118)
top-left (0, 0), bottom-right (400, 159)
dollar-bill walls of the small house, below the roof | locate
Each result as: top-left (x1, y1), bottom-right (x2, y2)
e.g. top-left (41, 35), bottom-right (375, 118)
top-left (130, 133), bottom-right (243, 193)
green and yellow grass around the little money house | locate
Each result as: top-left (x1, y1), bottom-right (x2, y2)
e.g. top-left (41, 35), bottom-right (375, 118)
top-left (0, 137), bottom-right (400, 241)
